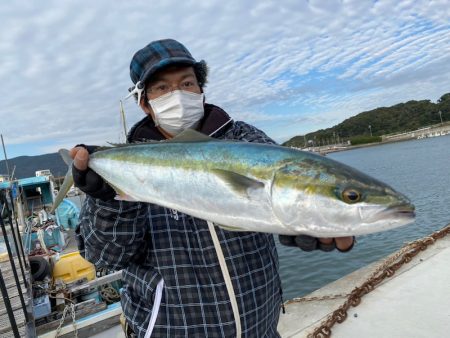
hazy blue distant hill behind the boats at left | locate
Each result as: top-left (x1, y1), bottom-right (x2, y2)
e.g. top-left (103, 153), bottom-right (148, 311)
top-left (0, 153), bottom-right (67, 178)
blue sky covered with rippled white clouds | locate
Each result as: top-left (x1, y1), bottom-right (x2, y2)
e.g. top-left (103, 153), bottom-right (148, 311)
top-left (0, 0), bottom-right (450, 159)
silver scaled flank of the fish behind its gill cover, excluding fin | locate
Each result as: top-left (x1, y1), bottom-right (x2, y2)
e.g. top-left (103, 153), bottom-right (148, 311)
top-left (90, 142), bottom-right (291, 233)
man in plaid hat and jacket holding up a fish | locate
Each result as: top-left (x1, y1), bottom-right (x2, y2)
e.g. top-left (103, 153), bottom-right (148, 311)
top-left (71, 39), bottom-right (353, 337)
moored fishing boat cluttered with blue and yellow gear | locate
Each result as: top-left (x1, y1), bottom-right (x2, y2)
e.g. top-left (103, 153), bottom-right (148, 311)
top-left (0, 170), bottom-right (121, 337)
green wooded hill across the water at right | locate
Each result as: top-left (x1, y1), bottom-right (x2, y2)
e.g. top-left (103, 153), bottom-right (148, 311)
top-left (283, 93), bottom-right (450, 147)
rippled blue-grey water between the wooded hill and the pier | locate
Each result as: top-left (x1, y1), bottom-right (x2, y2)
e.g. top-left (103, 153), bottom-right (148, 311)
top-left (278, 135), bottom-right (450, 300)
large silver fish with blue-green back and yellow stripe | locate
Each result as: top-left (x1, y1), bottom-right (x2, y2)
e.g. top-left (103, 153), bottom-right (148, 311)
top-left (52, 130), bottom-right (414, 237)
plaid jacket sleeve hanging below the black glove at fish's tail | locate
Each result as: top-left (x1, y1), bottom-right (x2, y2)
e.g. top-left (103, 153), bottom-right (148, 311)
top-left (76, 196), bottom-right (149, 270)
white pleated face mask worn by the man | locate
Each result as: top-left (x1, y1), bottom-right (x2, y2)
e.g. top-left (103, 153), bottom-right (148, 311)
top-left (148, 90), bottom-right (204, 136)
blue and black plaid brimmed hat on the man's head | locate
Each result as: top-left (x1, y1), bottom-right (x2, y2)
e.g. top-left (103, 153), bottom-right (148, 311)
top-left (129, 39), bottom-right (208, 102)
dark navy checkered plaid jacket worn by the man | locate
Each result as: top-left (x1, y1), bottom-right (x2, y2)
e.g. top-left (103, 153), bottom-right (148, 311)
top-left (77, 105), bottom-right (282, 337)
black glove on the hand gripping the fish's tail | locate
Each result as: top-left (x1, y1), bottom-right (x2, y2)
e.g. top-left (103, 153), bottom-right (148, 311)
top-left (72, 144), bottom-right (116, 201)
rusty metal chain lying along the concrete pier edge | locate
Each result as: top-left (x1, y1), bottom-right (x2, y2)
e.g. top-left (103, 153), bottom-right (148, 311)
top-left (308, 224), bottom-right (450, 338)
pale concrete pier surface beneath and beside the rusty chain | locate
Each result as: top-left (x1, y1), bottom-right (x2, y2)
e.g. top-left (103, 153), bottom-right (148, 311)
top-left (278, 227), bottom-right (450, 338)
